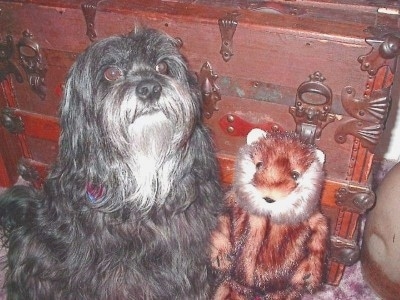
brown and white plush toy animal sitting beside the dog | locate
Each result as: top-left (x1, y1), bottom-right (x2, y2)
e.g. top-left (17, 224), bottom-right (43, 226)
top-left (211, 129), bottom-right (328, 300)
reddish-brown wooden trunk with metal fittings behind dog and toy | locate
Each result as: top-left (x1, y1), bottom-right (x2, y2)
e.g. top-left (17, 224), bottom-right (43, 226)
top-left (0, 0), bottom-right (400, 285)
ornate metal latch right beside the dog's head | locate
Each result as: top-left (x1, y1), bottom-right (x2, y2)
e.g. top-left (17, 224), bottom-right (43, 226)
top-left (197, 61), bottom-right (221, 119)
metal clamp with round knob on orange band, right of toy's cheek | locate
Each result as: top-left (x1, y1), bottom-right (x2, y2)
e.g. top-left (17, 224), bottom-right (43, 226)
top-left (335, 186), bottom-right (375, 214)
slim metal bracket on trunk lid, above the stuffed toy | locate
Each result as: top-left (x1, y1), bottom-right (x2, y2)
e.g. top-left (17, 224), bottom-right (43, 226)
top-left (218, 12), bottom-right (239, 62)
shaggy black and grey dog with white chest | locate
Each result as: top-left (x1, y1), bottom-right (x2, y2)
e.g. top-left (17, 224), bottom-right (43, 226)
top-left (0, 28), bottom-right (221, 300)
